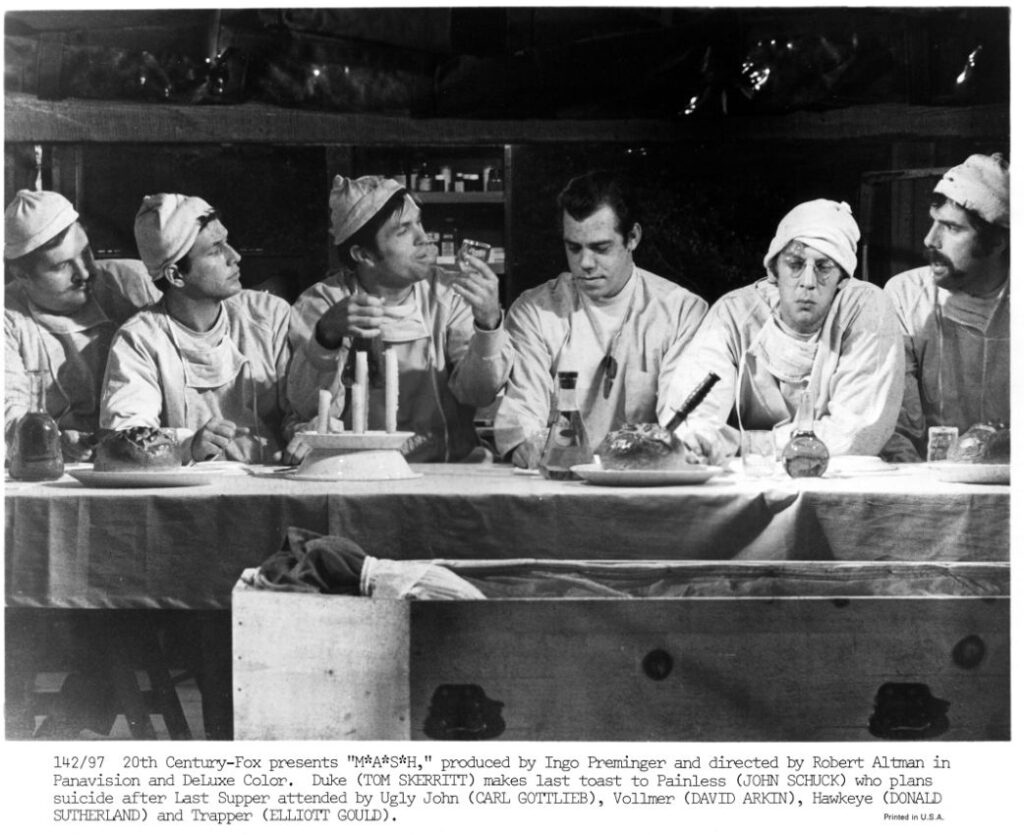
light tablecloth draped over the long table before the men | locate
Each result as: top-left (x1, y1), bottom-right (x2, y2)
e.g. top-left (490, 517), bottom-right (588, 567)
top-left (4, 464), bottom-right (1010, 609)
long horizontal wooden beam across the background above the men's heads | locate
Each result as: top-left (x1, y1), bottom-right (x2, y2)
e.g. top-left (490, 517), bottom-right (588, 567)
top-left (4, 93), bottom-right (1010, 147)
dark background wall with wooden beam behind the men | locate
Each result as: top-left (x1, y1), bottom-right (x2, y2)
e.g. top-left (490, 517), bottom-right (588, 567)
top-left (4, 6), bottom-right (1010, 302)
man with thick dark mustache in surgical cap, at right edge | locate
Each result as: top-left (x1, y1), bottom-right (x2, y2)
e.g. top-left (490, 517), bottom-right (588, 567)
top-left (886, 154), bottom-right (1010, 461)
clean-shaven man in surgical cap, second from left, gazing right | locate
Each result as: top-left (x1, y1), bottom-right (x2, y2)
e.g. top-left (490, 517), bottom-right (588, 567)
top-left (100, 194), bottom-right (291, 463)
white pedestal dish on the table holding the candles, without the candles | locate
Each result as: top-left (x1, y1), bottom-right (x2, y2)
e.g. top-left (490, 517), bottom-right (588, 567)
top-left (287, 431), bottom-right (422, 482)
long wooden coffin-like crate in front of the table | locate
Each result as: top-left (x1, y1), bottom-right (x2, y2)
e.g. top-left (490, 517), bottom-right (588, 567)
top-left (232, 569), bottom-right (1010, 742)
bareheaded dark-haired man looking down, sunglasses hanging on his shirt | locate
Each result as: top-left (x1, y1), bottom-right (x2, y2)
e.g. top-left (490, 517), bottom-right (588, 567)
top-left (495, 171), bottom-right (708, 469)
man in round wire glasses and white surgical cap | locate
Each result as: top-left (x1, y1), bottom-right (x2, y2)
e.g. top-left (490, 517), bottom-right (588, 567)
top-left (660, 200), bottom-right (903, 459)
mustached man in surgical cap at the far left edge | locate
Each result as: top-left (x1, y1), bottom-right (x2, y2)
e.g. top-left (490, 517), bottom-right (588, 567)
top-left (4, 190), bottom-right (160, 460)
